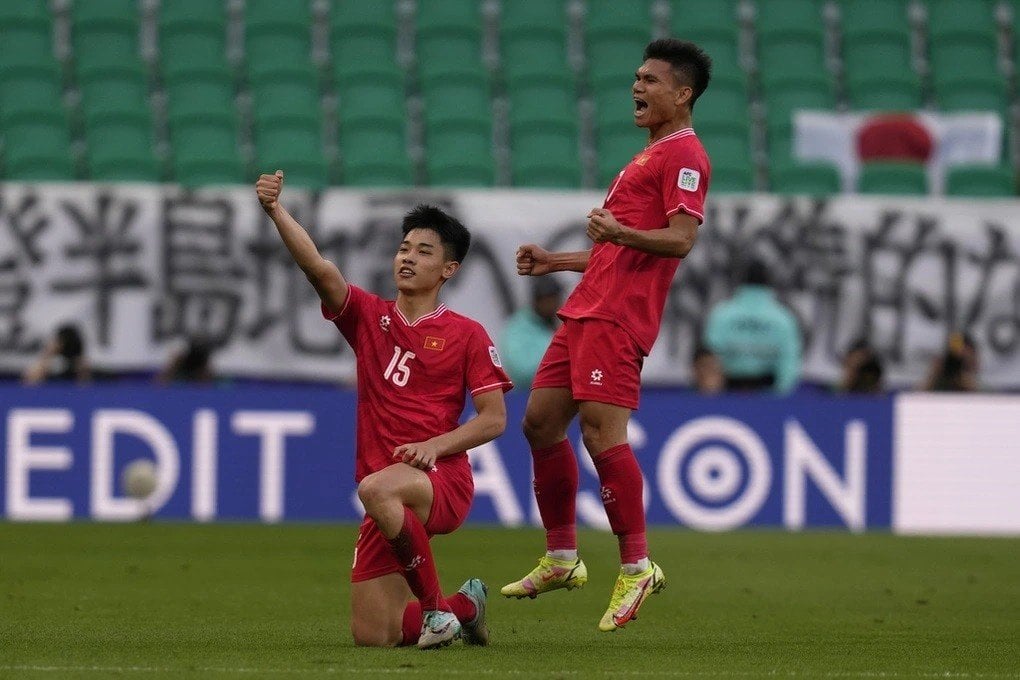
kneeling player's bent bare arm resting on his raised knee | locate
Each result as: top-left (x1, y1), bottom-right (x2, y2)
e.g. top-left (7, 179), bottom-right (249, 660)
top-left (393, 389), bottom-right (507, 470)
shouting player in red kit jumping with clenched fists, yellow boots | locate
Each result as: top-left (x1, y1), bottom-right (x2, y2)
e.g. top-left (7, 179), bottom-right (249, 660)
top-left (502, 39), bottom-right (712, 631)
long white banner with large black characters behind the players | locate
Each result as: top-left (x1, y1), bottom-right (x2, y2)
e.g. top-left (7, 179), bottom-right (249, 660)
top-left (0, 184), bottom-right (1020, 388)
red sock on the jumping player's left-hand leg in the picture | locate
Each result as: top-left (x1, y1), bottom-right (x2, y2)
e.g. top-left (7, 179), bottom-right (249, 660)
top-left (531, 439), bottom-right (578, 551)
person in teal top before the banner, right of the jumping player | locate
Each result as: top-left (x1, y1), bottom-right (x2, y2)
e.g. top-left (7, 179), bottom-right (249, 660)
top-left (705, 260), bottom-right (801, 395)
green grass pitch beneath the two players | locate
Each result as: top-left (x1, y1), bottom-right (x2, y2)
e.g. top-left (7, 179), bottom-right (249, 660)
top-left (0, 522), bottom-right (1020, 680)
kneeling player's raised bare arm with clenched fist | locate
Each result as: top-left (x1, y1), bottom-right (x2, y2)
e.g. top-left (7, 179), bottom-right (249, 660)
top-left (255, 170), bottom-right (348, 312)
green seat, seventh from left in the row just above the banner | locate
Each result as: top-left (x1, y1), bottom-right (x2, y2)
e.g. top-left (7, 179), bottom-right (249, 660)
top-left (510, 125), bottom-right (580, 188)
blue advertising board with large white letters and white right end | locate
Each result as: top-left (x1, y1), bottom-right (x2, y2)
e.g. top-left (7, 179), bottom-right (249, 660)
top-left (0, 386), bottom-right (1020, 534)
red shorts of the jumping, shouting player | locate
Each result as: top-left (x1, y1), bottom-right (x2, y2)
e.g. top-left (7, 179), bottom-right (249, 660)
top-left (531, 319), bottom-right (645, 410)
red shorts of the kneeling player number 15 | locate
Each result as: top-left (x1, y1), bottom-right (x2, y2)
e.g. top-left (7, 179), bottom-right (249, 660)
top-left (351, 457), bottom-right (474, 582)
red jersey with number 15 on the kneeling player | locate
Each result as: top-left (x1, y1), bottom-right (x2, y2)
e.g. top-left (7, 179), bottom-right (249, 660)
top-left (322, 285), bottom-right (513, 481)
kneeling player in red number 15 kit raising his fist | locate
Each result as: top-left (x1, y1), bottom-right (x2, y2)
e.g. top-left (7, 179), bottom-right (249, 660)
top-left (256, 170), bottom-right (512, 649)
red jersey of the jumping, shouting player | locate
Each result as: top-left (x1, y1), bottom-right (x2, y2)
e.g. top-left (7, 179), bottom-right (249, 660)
top-left (559, 127), bottom-right (712, 355)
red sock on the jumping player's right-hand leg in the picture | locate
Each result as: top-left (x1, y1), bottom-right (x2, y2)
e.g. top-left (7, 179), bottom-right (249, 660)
top-left (595, 443), bottom-right (648, 564)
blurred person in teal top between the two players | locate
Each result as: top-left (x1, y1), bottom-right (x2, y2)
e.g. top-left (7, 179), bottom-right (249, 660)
top-left (500, 276), bottom-right (563, 385)
